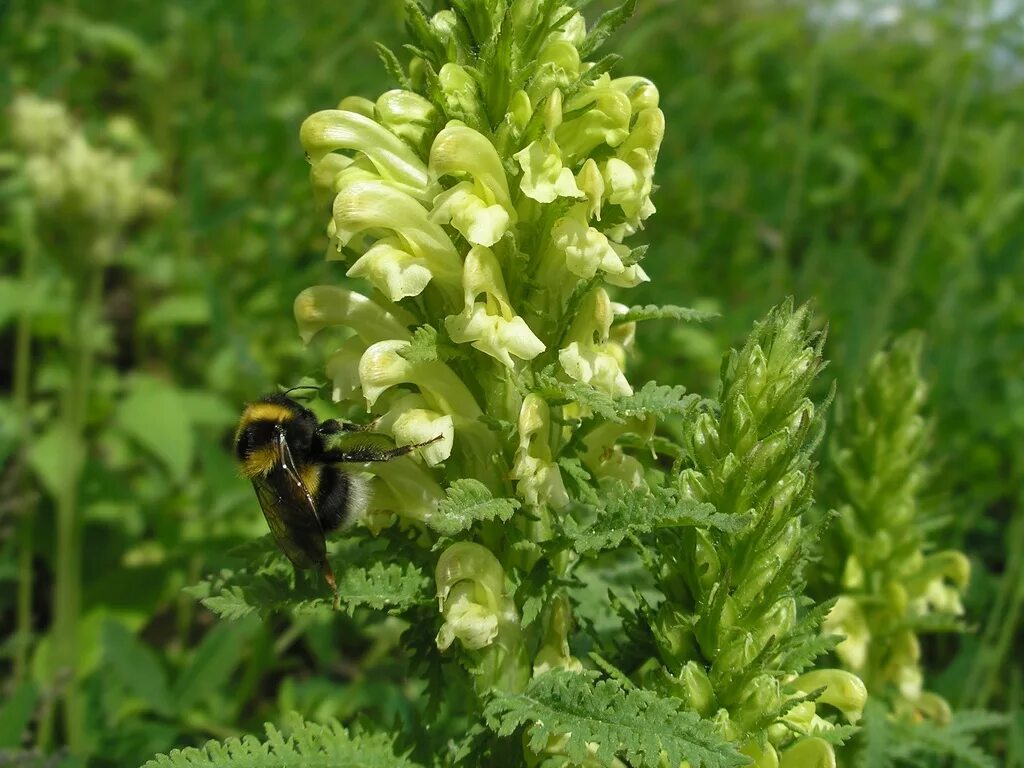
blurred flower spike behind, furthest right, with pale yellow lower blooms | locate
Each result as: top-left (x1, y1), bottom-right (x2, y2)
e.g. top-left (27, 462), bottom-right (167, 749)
top-left (825, 335), bottom-right (970, 722)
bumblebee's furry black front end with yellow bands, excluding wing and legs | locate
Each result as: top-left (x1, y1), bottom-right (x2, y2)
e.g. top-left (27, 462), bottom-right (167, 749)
top-left (234, 394), bottom-right (322, 477)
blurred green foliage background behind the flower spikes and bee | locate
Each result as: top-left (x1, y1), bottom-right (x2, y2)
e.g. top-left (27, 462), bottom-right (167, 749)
top-left (0, 0), bottom-right (1024, 766)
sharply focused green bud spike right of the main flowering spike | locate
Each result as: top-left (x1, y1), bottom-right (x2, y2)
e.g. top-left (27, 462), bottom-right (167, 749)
top-left (644, 305), bottom-right (866, 768)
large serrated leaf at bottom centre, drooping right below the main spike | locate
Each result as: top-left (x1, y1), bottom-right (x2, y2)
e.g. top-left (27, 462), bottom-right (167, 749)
top-left (484, 670), bottom-right (748, 768)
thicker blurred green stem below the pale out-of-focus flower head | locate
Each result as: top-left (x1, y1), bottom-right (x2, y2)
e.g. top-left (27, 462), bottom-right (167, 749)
top-left (53, 249), bottom-right (103, 754)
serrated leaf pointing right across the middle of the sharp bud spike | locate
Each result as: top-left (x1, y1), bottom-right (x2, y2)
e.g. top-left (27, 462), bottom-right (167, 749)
top-left (565, 483), bottom-right (746, 554)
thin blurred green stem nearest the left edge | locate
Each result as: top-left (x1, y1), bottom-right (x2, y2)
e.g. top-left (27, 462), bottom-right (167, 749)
top-left (14, 205), bottom-right (38, 687)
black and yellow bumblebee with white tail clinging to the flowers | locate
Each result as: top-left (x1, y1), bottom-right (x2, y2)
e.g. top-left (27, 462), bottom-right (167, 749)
top-left (234, 389), bottom-right (439, 608)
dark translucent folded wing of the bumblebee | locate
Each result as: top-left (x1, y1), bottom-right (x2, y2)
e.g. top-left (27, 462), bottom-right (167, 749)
top-left (253, 432), bottom-right (327, 568)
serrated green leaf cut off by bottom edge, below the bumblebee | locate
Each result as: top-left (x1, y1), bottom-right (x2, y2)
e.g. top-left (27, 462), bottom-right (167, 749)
top-left (142, 713), bottom-right (416, 768)
